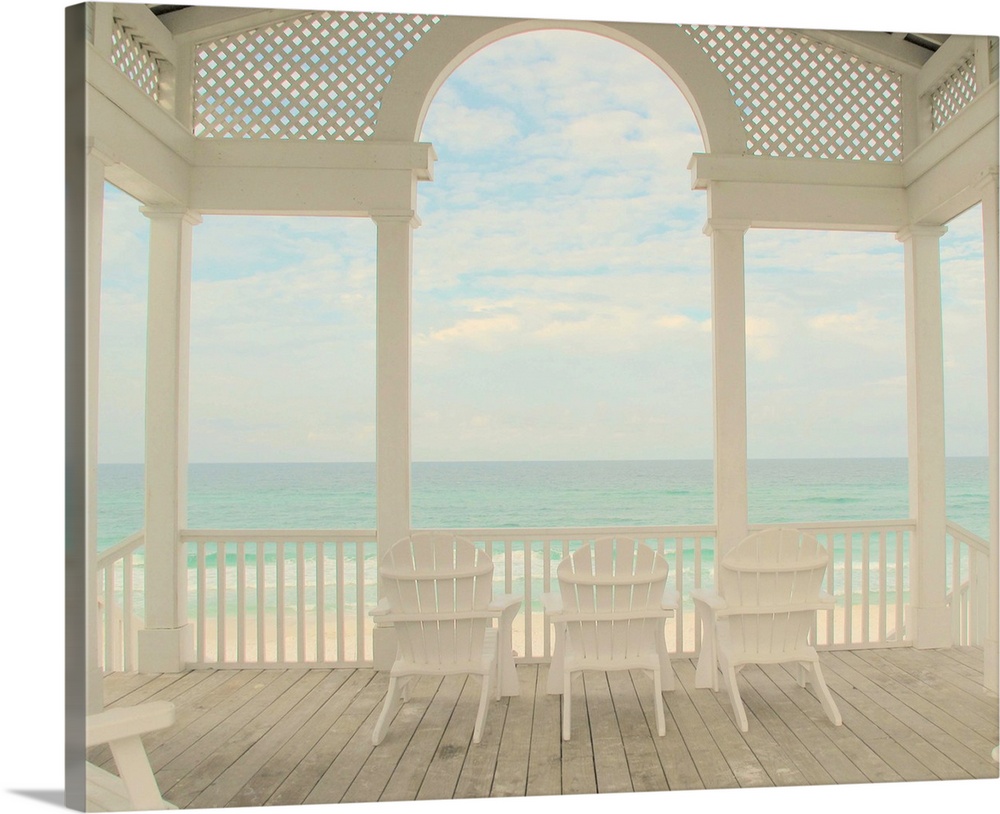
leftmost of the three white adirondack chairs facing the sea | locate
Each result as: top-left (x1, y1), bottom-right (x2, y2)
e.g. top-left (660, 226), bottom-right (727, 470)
top-left (372, 533), bottom-right (521, 746)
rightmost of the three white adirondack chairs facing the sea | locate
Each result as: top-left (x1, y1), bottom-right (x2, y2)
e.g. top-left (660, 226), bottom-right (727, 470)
top-left (691, 528), bottom-right (841, 732)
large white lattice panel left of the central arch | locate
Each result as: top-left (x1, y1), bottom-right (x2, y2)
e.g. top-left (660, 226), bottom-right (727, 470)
top-left (194, 12), bottom-right (439, 141)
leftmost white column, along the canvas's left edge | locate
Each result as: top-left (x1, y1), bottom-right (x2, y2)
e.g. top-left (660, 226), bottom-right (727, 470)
top-left (83, 146), bottom-right (113, 713)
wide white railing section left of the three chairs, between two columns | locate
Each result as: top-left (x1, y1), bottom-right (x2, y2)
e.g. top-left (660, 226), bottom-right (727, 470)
top-left (181, 530), bottom-right (378, 667)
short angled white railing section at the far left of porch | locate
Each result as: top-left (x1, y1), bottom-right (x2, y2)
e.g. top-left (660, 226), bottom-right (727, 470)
top-left (96, 531), bottom-right (146, 673)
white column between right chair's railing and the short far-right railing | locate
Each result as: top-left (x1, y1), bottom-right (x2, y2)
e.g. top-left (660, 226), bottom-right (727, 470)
top-left (896, 226), bottom-right (951, 648)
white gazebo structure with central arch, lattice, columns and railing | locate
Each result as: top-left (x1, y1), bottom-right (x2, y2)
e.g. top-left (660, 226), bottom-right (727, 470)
top-left (67, 2), bottom-right (1000, 808)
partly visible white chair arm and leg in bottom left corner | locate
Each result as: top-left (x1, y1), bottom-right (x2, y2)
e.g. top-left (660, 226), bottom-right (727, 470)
top-left (86, 701), bottom-right (177, 811)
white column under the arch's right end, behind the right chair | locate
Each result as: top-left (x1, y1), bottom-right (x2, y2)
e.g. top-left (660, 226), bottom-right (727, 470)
top-left (705, 218), bottom-right (750, 558)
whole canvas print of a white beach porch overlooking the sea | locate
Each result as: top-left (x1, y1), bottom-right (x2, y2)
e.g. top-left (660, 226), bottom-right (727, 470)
top-left (66, 2), bottom-right (1000, 811)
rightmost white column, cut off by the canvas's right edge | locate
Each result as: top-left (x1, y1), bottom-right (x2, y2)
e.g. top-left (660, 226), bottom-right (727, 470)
top-left (980, 174), bottom-right (1000, 692)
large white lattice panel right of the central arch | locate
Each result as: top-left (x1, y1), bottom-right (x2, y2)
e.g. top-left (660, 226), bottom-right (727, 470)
top-left (684, 26), bottom-right (903, 161)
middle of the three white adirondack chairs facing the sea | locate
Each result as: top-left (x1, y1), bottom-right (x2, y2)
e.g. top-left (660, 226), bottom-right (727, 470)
top-left (542, 537), bottom-right (677, 740)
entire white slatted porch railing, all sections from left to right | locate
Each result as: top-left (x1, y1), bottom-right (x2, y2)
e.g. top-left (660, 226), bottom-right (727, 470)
top-left (98, 520), bottom-right (989, 671)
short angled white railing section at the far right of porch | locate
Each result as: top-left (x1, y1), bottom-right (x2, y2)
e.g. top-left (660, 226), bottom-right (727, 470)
top-left (945, 522), bottom-right (990, 645)
